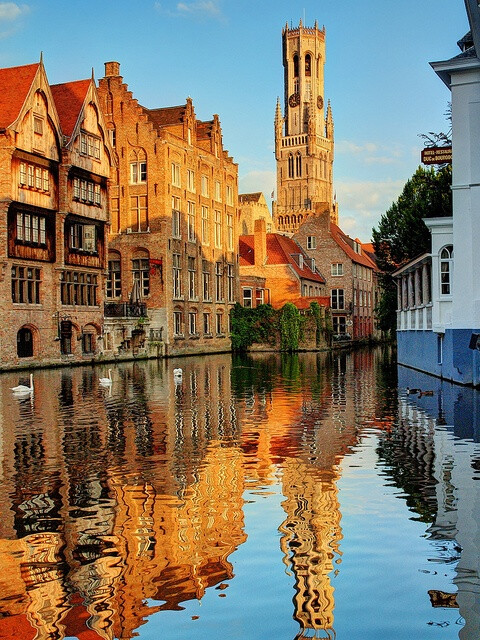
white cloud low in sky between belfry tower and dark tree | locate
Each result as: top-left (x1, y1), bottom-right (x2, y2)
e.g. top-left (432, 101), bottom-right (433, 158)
top-left (335, 180), bottom-right (405, 242)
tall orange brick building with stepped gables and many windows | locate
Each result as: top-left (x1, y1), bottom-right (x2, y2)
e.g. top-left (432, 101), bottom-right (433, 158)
top-left (98, 62), bottom-right (238, 355)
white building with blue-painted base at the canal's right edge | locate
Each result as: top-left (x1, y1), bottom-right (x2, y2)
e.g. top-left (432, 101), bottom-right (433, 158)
top-left (396, 0), bottom-right (480, 386)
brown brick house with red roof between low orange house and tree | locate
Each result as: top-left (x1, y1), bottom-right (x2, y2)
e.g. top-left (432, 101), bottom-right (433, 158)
top-left (293, 213), bottom-right (378, 339)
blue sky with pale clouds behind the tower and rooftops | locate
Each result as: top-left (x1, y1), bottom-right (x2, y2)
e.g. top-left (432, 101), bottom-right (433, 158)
top-left (0, 0), bottom-right (468, 241)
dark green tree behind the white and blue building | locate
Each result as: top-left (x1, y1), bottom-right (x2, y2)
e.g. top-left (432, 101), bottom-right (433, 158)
top-left (372, 165), bottom-right (452, 333)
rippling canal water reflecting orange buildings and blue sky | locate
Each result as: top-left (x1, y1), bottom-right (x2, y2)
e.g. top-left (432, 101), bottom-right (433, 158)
top-left (0, 348), bottom-right (480, 640)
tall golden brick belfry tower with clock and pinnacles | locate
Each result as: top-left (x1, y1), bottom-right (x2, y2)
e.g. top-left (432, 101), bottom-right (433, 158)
top-left (273, 21), bottom-right (338, 234)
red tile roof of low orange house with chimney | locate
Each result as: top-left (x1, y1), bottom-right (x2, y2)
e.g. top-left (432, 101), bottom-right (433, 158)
top-left (239, 233), bottom-right (325, 284)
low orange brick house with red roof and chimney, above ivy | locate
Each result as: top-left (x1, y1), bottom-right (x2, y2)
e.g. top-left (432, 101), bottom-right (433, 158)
top-left (239, 219), bottom-right (329, 309)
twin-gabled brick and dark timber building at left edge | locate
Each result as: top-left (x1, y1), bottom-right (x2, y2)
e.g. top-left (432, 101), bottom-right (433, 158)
top-left (0, 61), bottom-right (112, 368)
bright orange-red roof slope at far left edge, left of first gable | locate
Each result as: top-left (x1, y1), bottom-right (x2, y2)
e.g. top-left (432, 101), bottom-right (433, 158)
top-left (0, 62), bottom-right (40, 129)
